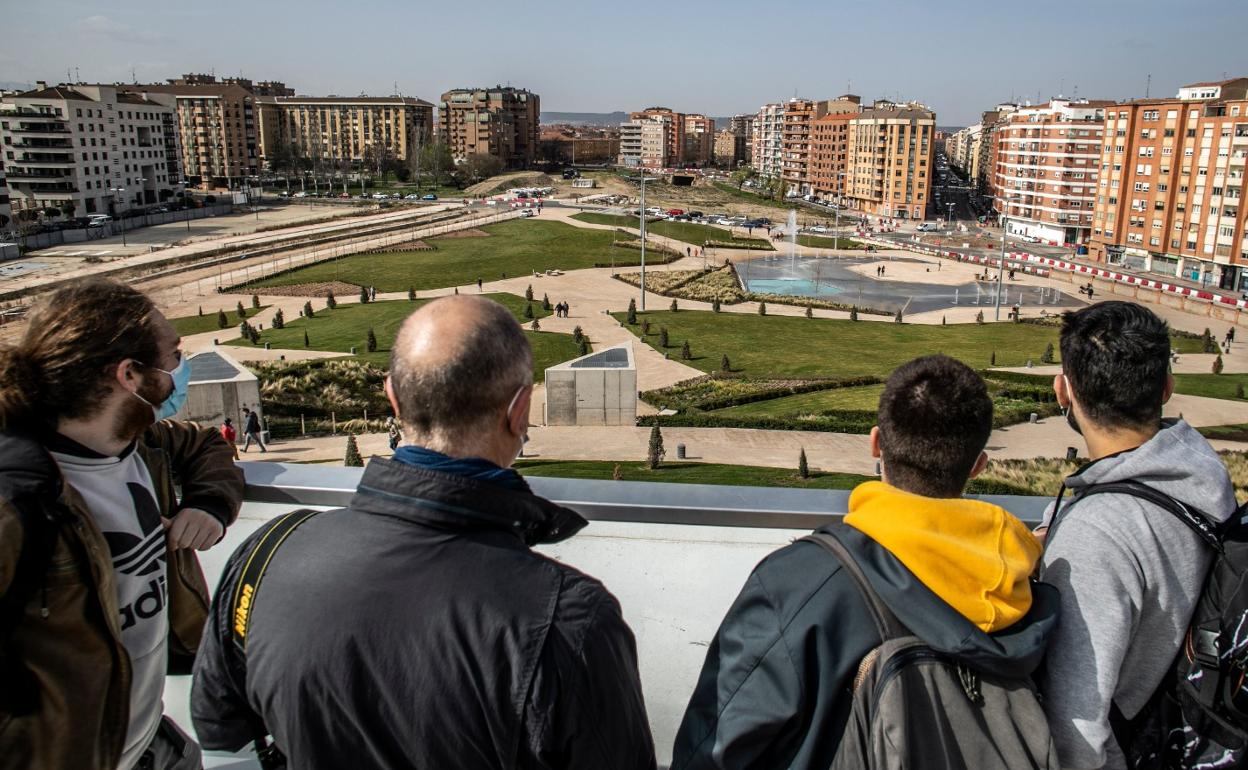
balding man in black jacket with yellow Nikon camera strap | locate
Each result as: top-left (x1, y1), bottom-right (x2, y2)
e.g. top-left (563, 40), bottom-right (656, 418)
top-left (191, 296), bottom-right (655, 770)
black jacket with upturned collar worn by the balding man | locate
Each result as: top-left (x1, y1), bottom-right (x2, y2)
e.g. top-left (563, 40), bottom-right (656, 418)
top-left (191, 459), bottom-right (655, 770)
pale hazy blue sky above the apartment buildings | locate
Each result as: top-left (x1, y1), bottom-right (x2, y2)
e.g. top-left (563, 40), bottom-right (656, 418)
top-left (0, 0), bottom-right (1248, 126)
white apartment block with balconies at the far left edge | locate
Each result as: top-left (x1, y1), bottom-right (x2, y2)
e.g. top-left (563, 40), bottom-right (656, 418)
top-left (0, 82), bottom-right (182, 216)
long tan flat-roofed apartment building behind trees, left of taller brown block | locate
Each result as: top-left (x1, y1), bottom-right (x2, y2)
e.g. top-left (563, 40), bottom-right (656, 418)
top-left (256, 96), bottom-right (433, 168)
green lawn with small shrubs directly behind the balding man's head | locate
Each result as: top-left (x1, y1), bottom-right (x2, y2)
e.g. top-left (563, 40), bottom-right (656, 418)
top-left (225, 293), bottom-right (580, 382)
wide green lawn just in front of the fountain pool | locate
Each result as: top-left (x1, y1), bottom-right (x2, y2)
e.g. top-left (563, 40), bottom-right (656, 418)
top-left (615, 311), bottom-right (1057, 378)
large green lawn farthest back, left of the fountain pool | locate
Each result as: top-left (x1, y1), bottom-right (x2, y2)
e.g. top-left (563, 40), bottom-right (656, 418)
top-left (251, 220), bottom-right (640, 295)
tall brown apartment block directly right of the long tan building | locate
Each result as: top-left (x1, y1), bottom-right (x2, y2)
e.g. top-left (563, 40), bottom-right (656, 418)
top-left (438, 86), bottom-right (542, 168)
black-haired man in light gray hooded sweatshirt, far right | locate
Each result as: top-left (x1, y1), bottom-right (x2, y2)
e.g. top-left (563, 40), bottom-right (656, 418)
top-left (1041, 302), bottom-right (1236, 768)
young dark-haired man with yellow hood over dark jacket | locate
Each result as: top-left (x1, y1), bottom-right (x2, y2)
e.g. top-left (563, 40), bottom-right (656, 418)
top-left (671, 356), bottom-right (1057, 770)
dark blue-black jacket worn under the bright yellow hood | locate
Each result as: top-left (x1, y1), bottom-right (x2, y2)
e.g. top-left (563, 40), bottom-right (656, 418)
top-left (671, 524), bottom-right (1057, 770)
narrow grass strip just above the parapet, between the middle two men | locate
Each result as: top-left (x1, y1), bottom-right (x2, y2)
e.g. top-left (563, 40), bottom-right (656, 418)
top-left (515, 457), bottom-right (872, 489)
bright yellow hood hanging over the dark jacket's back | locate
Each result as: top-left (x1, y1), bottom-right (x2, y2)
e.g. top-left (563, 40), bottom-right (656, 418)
top-left (845, 482), bottom-right (1041, 631)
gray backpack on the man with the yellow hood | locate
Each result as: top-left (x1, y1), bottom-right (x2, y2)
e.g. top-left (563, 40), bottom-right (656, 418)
top-left (804, 533), bottom-right (1060, 770)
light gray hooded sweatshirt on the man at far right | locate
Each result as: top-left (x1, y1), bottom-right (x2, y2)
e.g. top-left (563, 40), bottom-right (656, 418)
top-left (1040, 419), bottom-right (1236, 770)
